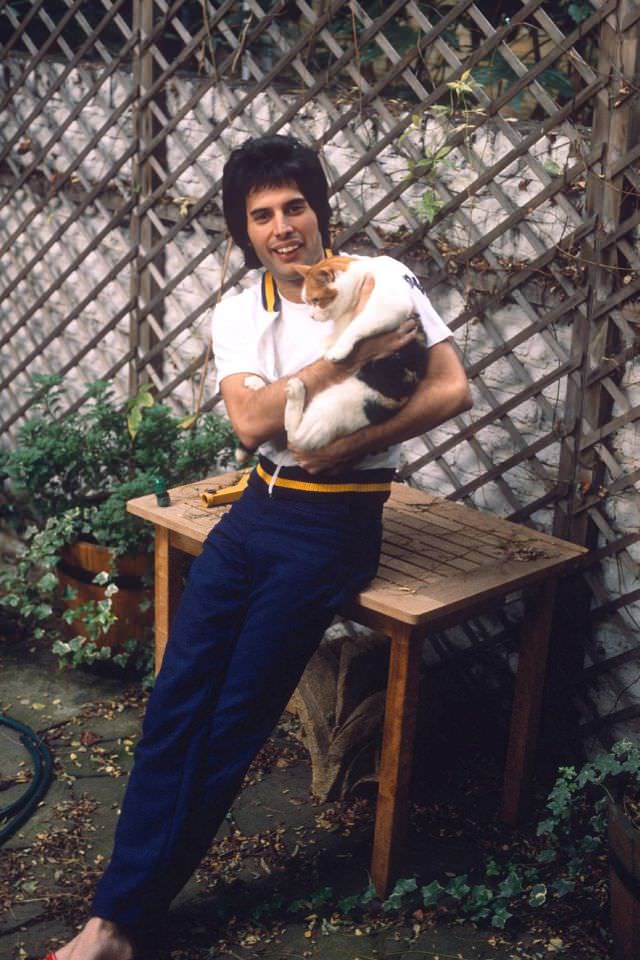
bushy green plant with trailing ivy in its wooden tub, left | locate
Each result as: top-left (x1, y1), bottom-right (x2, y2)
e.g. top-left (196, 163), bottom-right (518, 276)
top-left (0, 376), bottom-right (235, 665)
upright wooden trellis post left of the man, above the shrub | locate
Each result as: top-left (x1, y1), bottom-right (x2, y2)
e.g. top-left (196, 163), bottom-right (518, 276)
top-left (129, 0), bottom-right (167, 396)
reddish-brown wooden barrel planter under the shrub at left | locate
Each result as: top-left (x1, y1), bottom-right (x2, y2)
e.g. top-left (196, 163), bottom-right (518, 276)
top-left (57, 540), bottom-right (153, 651)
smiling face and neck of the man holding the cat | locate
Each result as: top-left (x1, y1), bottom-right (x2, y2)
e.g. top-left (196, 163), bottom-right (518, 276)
top-left (247, 184), bottom-right (324, 302)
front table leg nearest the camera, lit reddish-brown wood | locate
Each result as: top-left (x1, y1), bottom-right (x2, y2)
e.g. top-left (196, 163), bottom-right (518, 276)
top-left (371, 623), bottom-right (422, 898)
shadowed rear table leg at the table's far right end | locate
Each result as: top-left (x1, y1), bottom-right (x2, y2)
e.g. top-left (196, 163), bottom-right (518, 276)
top-left (502, 578), bottom-right (557, 825)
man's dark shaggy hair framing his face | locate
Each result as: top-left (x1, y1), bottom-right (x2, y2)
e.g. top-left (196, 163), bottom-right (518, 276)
top-left (222, 136), bottom-right (331, 269)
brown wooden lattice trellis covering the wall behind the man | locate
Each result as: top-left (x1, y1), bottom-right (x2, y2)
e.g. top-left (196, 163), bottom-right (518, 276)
top-left (0, 0), bottom-right (640, 748)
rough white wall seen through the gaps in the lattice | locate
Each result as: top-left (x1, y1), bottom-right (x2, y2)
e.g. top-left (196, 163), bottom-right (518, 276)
top-left (0, 58), bottom-right (640, 744)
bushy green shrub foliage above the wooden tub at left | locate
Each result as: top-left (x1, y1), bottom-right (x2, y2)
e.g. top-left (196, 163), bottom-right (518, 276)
top-left (0, 375), bottom-right (235, 554)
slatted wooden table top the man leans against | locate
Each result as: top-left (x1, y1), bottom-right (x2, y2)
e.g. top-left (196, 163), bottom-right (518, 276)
top-left (127, 473), bottom-right (587, 624)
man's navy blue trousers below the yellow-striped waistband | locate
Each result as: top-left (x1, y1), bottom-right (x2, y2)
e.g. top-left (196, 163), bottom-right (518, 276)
top-left (92, 487), bottom-right (382, 935)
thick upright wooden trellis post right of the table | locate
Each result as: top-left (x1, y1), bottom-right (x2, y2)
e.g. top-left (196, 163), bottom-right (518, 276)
top-left (554, 0), bottom-right (640, 547)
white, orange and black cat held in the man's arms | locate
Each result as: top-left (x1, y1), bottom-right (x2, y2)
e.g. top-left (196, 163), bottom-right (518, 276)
top-left (284, 256), bottom-right (427, 450)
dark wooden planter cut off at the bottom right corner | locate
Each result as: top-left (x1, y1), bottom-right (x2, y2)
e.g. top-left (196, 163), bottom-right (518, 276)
top-left (608, 801), bottom-right (640, 960)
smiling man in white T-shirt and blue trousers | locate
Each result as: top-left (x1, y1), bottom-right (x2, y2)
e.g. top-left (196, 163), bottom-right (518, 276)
top-left (41, 137), bottom-right (470, 960)
